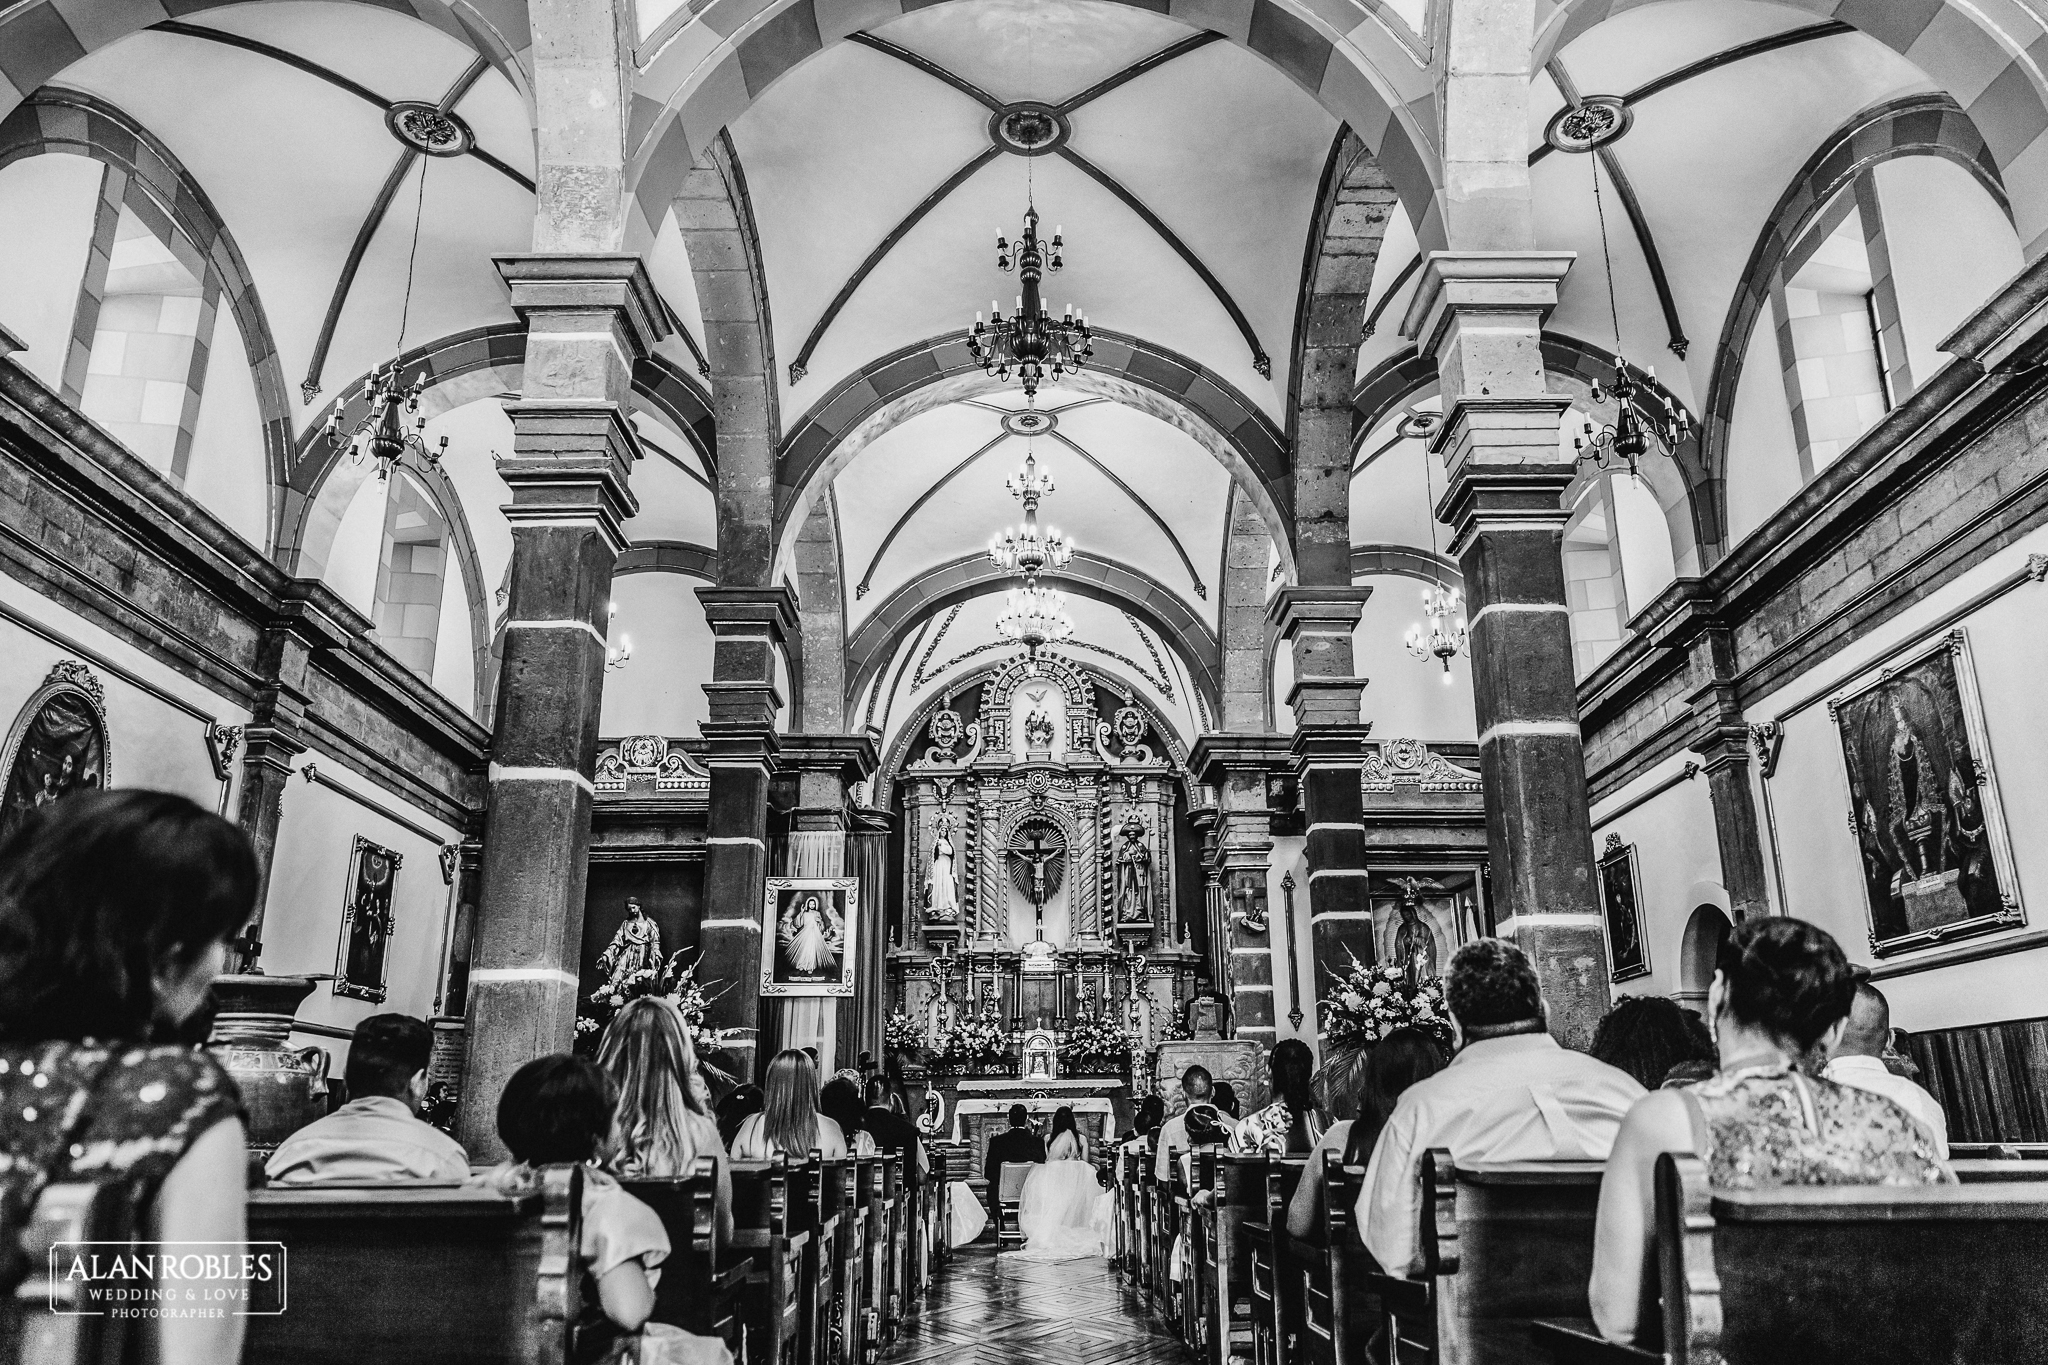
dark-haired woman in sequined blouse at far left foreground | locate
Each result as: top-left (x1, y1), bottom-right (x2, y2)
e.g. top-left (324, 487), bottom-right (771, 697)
top-left (0, 790), bottom-right (256, 1365)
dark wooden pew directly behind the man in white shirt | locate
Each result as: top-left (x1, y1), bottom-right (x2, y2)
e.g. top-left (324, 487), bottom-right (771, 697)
top-left (1366, 1148), bottom-right (1602, 1365)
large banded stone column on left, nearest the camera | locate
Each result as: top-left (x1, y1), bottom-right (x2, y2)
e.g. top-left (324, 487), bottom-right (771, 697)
top-left (461, 254), bottom-right (666, 1160)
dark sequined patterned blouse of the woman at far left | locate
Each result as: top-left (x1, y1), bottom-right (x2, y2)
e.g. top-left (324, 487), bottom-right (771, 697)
top-left (0, 1042), bottom-right (242, 1207)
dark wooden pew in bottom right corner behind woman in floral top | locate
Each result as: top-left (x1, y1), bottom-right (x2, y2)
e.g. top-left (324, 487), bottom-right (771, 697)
top-left (1534, 1152), bottom-right (2048, 1365)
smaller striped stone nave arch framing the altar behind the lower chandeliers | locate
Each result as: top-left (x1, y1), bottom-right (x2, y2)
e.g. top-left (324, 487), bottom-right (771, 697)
top-left (846, 551), bottom-right (1221, 714)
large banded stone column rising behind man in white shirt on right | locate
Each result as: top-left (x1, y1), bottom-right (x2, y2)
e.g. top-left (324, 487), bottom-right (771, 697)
top-left (1409, 252), bottom-right (1608, 1048)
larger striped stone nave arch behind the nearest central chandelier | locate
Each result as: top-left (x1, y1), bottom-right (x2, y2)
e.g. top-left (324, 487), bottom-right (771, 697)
top-left (774, 332), bottom-right (1294, 571)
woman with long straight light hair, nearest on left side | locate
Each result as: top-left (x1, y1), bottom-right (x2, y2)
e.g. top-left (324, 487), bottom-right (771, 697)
top-left (598, 995), bottom-right (733, 1242)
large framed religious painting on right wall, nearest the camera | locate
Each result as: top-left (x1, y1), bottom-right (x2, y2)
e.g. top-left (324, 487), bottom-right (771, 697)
top-left (1827, 630), bottom-right (2025, 958)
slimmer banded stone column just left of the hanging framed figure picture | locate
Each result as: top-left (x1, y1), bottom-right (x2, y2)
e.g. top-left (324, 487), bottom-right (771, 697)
top-left (696, 587), bottom-right (797, 1074)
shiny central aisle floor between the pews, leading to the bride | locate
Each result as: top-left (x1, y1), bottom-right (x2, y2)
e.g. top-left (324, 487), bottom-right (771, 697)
top-left (883, 1242), bottom-right (1180, 1365)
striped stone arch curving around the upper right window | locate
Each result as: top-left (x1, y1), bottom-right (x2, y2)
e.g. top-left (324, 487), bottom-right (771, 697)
top-left (1694, 94), bottom-right (2007, 569)
